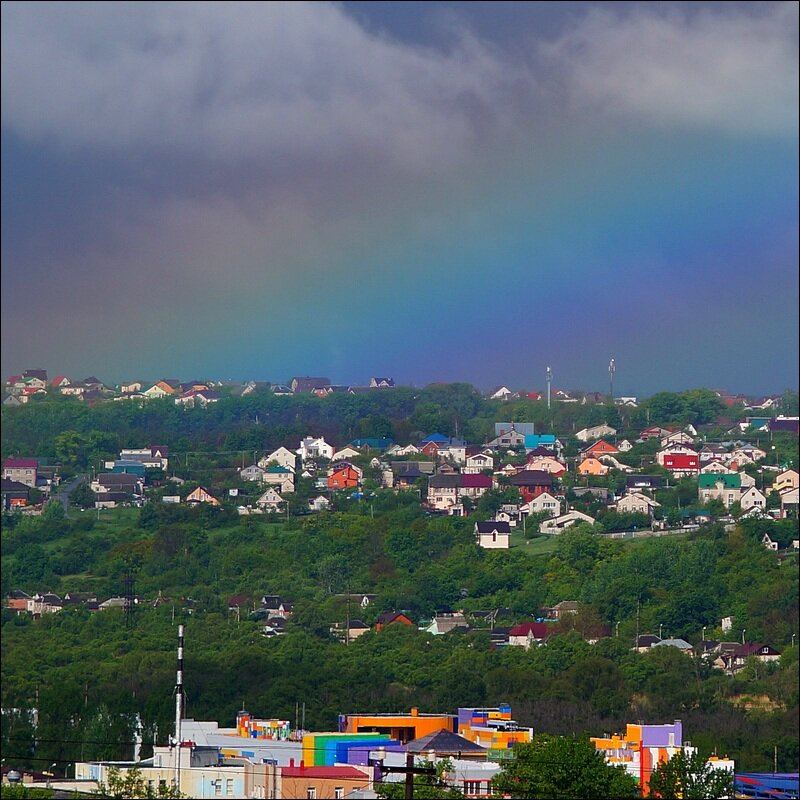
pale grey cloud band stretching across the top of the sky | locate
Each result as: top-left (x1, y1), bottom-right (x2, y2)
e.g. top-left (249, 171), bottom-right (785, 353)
top-left (2, 2), bottom-right (798, 173)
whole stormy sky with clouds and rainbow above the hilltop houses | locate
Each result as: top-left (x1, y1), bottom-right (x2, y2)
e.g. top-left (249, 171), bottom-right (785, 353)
top-left (2, 2), bottom-right (798, 394)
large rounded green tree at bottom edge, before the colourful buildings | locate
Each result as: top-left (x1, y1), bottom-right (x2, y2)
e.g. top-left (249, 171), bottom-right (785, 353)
top-left (492, 734), bottom-right (639, 800)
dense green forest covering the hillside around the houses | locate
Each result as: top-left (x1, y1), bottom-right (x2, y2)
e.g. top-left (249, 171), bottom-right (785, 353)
top-left (0, 384), bottom-right (799, 771)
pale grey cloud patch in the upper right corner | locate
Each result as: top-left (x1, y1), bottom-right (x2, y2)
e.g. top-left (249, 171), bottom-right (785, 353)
top-left (543, 2), bottom-right (798, 137)
